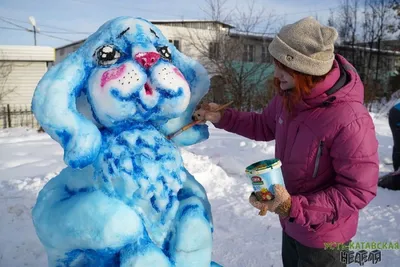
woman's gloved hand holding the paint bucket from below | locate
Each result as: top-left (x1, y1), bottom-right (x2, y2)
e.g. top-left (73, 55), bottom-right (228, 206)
top-left (249, 184), bottom-right (292, 218)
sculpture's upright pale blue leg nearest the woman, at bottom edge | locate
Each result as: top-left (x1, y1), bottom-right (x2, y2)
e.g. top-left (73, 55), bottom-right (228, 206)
top-left (170, 197), bottom-right (212, 267)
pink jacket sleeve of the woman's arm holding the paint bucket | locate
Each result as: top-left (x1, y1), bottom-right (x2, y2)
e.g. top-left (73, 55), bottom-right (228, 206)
top-left (289, 116), bottom-right (379, 227)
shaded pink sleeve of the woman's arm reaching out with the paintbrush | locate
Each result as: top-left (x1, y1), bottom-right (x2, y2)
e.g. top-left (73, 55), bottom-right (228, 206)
top-left (214, 97), bottom-right (277, 141)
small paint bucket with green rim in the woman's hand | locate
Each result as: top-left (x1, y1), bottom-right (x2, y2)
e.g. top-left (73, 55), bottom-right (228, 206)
top-left (246, 159), bottom-right (285, 201)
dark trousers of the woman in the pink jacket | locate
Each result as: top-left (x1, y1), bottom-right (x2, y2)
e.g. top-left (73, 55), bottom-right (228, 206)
top-left (282, 232), bottom-right (348, 267)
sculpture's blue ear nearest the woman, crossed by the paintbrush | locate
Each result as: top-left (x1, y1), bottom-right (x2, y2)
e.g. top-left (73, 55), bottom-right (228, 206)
top-left (161, 47), bottom-right (210, 146)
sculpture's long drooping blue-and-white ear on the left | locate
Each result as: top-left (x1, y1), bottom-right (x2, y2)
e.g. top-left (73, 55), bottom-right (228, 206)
top-left (32, 50), bottom-right (101, 168)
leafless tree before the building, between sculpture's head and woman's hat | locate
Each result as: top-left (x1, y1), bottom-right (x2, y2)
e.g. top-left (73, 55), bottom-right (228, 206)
top-left (183, 0), bottom-right (275, 110)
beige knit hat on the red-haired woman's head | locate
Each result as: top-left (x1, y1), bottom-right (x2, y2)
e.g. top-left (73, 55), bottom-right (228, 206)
top-left (268, 17), bottom-right (338, 76)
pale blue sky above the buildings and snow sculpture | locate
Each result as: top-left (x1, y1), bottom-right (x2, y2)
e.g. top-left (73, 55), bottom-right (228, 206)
top-left (0, 0), bottom-right (340, 47)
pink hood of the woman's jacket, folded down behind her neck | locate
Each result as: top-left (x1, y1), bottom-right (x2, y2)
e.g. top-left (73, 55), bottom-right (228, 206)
top-left (298, 54), bottom-right (364, 110)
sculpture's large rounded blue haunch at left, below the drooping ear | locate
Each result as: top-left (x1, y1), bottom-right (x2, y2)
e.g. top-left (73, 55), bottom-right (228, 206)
top-left (32, 168), bottom-right (144, 252)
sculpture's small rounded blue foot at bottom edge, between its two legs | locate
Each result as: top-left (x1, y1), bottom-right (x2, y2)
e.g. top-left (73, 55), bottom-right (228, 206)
top-left (120, 243), bottom-right (173, 267)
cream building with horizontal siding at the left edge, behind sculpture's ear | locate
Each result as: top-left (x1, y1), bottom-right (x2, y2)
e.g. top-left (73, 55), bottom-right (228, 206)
top-left (0, 45), bottom-right (55, 105)
